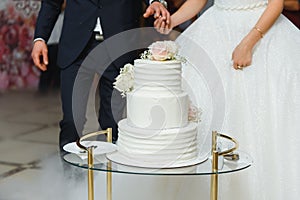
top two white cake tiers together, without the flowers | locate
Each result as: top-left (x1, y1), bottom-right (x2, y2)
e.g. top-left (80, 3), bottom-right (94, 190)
top-left (127, 59), bottom-right (188, 129)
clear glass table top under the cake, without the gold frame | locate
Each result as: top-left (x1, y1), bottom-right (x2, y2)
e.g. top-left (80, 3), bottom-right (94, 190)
top-left (63, 151), bottom-right (253, 175)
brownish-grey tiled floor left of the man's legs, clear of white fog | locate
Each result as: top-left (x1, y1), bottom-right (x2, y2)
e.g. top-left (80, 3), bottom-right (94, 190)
top-left (0, 91), bottom-right (61, 200)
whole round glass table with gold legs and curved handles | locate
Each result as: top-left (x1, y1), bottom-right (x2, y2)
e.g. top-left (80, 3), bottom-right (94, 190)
top-left (63, 128), bottom-right (252, 200)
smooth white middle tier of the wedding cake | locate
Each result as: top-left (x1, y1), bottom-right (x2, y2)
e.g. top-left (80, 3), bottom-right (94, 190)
top-left (127, 90), bottom-right (188, 129)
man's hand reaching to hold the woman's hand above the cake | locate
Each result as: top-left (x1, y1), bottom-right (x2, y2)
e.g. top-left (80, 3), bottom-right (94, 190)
top-left (143, 1), bottom-right (170, 25)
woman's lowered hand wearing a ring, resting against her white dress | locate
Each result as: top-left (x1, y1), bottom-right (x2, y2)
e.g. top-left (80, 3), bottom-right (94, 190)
top-left (232, 41), bottom-right (252, 70)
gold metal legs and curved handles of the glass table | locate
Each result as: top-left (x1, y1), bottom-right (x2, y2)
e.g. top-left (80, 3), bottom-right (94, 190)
top-left (76, 128), bottom-right (245, 200)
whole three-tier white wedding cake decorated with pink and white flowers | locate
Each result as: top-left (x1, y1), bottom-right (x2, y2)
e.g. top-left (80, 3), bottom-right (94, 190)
top-left (108, 41), bottom-right (202, 168)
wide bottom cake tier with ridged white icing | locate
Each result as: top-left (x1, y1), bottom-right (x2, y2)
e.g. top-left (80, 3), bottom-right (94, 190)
top-left (118, 119), bottom-right (198, 165)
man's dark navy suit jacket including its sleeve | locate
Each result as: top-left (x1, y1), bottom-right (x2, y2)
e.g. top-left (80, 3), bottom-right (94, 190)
top-left (34, 0), bottom-right (148, 68)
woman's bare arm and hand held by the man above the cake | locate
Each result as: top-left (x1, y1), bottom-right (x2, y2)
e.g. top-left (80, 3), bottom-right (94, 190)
top-left (154, 0), bottom-right (207, 34)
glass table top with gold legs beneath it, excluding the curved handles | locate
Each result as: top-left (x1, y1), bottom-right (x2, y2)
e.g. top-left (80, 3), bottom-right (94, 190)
top-left (63, 151), bottom-right (253, 200)
